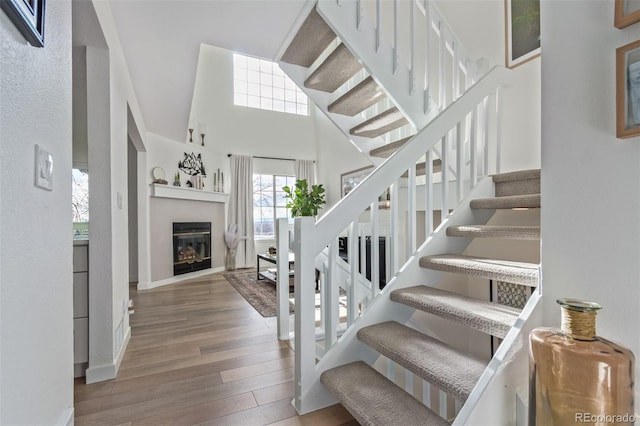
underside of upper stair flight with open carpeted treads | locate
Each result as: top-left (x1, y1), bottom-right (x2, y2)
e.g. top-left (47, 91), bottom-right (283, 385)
top-left (280, 8), bottom-right (415, 163)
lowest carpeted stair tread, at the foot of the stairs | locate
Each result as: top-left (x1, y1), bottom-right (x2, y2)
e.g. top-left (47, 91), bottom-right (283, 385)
top-left (320, 361), bottom-right (449, 426)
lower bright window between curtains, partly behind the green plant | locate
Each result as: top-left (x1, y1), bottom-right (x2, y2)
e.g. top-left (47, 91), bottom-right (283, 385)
top-left (253, 174), bottom-right (296, 239)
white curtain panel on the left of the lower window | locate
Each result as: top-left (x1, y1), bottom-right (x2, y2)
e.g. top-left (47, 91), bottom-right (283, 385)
top-left (229, 154), bottom-right (256, 268)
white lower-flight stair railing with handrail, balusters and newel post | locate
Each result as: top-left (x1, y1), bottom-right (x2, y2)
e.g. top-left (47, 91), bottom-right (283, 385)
top-left (293, 67), bottom-right (508, 413)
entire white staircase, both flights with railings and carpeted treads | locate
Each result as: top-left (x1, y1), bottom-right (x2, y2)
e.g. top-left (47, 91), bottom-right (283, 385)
top-left (278, 0), bottom-right (540, 425)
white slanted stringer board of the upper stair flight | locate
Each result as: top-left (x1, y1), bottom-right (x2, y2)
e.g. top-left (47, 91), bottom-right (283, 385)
top-left (316, 1), bottom-right (440, 129)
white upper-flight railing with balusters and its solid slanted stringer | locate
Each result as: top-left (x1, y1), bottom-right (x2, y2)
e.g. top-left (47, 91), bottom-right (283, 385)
top-left (317, 0), bottom-right (486, 129)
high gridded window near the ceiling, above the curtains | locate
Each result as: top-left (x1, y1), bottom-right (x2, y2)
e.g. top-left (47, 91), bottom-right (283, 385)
top-left (233, 53), bottom-right (309, 115)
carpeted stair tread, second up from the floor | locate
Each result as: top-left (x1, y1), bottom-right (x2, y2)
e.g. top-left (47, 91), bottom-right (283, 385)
top-left (358, 321), bottom-right (486, 402)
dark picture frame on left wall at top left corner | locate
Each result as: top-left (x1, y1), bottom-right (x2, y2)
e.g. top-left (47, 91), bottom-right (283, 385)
top-left (0, 0), bottom-right (46, 47)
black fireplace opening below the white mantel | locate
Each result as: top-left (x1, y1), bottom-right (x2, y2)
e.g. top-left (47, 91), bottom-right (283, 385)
top-left (173, 222), bottom-right (211, 275)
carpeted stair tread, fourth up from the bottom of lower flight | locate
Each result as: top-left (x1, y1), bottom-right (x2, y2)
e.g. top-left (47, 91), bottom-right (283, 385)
top-left (420, 254), bottom-right (538, 287)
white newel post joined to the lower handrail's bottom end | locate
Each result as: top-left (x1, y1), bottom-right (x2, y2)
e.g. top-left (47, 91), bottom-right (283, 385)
top-left (293, 217), bottom-right (316, 413)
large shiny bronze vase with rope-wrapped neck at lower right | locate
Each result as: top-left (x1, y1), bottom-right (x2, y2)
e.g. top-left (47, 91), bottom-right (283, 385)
top-left (529, 299), bottom-right (635, 426)
